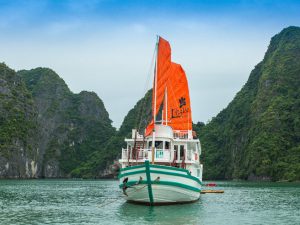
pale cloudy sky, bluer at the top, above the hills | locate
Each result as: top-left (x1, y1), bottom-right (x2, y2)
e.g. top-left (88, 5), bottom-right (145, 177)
top-left (0, 0), bottom-right (300, 128)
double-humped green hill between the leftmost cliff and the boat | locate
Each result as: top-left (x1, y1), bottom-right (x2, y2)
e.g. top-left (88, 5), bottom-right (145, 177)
top-left (18, 68), bottom-right (115, 177)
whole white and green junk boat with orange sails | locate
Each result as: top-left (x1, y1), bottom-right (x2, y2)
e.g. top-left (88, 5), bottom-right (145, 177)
top-left (118, 37), bottom-right (203, 205)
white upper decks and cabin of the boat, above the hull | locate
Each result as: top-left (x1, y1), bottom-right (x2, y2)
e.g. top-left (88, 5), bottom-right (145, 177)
top-left (119, 125), bottom-right (201, 167)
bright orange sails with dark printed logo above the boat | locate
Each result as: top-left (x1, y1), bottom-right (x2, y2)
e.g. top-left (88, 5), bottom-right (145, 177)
top-left (145, 37), bottom-right (192, 136)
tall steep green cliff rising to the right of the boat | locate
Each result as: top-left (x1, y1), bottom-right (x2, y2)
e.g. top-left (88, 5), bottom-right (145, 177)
top-left (198, 27), bottom-right (300, 180)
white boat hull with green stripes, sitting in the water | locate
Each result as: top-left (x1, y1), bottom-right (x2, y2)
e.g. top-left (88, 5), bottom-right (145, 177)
top-left (119, 162), bottom-right (201, 205)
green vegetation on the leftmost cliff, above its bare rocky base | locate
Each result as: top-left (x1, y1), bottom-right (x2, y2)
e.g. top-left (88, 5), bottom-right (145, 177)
top-left (0, 63), bottom-right (37, 160)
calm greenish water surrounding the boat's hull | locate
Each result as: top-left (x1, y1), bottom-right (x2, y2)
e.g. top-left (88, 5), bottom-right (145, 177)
top-left (0, 180), bottom-right (300, 225)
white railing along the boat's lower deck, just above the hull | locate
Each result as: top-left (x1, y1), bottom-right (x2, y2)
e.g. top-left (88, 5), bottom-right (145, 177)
top-left (121, 149), bottom-right (198, 163)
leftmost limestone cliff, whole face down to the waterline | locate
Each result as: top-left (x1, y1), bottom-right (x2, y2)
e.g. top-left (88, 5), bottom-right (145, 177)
top-left (0, 63), bottom-right (39, 178)
